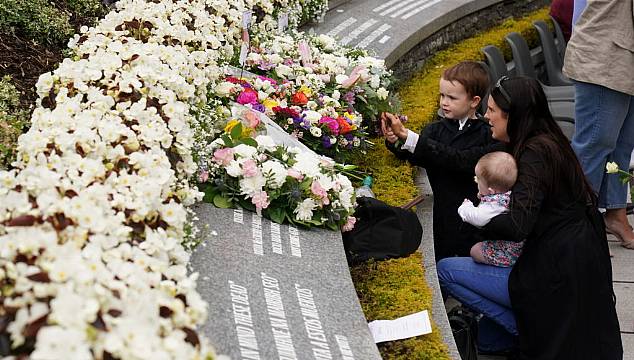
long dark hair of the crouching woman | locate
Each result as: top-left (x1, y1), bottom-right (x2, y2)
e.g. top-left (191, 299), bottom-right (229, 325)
top-left (491, 77), bottom-right (597, 206)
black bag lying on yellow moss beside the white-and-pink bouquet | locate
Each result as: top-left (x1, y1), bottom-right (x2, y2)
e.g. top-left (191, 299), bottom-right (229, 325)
top-left (342, 197), bottom-right (423, 264)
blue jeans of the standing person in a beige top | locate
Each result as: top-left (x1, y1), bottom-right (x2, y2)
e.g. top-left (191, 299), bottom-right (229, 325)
top-left (572, 81), bottom-right (634, 209)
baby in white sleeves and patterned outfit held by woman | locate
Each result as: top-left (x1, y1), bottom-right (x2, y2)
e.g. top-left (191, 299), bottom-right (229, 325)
top-left (458, 151), bottom-right (524, 267)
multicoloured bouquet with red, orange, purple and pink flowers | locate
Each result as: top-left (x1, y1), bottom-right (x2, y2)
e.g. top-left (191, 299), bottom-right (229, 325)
top-left (214, 75), bottom-right (369, 162)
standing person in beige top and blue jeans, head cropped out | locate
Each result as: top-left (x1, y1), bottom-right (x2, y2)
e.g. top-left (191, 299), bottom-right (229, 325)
top-left (563, 0), bottom-right (634, 249)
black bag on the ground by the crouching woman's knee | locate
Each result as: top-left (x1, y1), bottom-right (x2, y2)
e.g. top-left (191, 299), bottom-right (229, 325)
top-left (447, 306), bottom-right (478, 360)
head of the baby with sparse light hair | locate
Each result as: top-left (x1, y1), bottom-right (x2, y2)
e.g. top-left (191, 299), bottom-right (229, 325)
top-left (475, 151), bottom-right (517, 192)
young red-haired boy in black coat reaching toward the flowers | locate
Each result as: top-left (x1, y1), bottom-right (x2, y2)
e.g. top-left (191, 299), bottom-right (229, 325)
top-left (381, 61), bottom-right (504, 261)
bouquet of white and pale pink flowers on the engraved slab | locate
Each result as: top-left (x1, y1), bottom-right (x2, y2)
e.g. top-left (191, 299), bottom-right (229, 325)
top-left (198, 122), bottom-right (355, 230)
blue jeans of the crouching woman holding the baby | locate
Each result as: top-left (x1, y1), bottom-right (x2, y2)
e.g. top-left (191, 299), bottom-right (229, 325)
top-left (436, 257), bottom-right (518, 351)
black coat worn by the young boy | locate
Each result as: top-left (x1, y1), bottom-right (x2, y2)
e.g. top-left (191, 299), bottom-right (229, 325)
top-left (386, 117), bottom-right (506, 261)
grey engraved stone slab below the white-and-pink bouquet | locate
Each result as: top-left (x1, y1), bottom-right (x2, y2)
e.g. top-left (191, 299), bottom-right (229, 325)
top-left (191, 204), bottom-right (381, 360)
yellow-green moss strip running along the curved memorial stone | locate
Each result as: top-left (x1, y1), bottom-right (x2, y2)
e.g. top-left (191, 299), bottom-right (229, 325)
top-left (351, 9), bottom-right (549, 359)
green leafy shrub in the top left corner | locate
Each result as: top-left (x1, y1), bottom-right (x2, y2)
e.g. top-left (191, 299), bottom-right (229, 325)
top-left (0, 0), bottom-right (106, 46)
